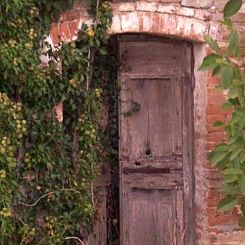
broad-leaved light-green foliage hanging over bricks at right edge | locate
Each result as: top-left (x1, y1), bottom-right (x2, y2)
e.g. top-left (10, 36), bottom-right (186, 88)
top-left (201, 0), bottom-right (245, 227)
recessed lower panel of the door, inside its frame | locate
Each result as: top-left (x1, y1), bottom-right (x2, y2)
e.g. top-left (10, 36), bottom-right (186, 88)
top-left (129, 188), bottom-right (177, 245)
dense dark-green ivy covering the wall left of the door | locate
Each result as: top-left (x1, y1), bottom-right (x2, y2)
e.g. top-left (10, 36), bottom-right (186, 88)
top-left (0, 0), bottom-right (117, 245)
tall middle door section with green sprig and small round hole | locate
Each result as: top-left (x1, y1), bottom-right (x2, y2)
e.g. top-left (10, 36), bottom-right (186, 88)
top-left (121, 77), bottom-right (182, 160)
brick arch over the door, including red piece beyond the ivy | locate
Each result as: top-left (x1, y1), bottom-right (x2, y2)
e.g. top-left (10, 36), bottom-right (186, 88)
top-left (50, 2), bottom-right (220, 44)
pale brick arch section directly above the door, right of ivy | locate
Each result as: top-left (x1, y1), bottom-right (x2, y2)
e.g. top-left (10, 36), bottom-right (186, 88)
top-left (111, 3), bottom-right (209, 42)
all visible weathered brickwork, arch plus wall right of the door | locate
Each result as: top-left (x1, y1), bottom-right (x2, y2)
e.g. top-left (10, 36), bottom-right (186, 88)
top-left (50, 0), bottom-right (245, 245)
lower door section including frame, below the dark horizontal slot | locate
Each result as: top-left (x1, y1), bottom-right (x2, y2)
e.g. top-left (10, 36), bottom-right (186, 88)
top-left (121, 177), bottom-right (184, 245)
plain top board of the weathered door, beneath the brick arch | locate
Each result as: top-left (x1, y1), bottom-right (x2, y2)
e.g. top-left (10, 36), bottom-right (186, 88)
top-left (120, 41), bottom-right (182, 76)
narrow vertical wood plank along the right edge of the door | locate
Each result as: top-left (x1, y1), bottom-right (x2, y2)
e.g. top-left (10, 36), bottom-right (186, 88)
top-left (182, 45), bottom-right (195, 244)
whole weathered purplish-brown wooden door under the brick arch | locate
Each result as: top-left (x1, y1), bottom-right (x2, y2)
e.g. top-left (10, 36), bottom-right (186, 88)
top-left (118, 35), bottom-right (194, 245)
